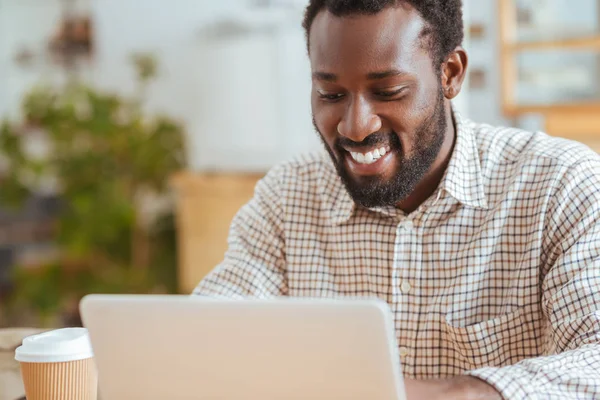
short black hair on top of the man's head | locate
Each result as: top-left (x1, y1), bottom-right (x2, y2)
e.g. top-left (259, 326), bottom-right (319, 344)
top-left (302, 0), bottom-right (464, 65)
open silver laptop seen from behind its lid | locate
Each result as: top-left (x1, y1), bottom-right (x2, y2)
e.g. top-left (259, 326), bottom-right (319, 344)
top-left (80, 295), bottom-right (405, 400)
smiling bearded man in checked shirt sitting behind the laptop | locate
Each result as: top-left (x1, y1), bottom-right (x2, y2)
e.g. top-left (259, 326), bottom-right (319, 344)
top-left (195, 0), bottom-right (600, 399)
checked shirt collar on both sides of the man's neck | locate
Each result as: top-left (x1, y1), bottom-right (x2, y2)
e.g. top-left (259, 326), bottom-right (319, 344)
top-left (321, 107), bottom-right (488, 225)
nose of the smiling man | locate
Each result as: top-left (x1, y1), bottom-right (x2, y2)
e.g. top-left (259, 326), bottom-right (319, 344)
top-left (337, 97), bottom-right (381, 142)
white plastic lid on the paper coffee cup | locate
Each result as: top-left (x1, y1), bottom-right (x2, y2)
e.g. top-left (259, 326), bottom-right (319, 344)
top-left (15, 328), bottom-right (94, 363)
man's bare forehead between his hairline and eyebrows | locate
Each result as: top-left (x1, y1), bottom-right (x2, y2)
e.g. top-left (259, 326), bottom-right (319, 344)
top-left (309, 5), bottom-right (430, 73)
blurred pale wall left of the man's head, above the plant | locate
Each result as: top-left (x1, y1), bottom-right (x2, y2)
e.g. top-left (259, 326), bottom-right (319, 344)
top-left (0, 0), bottom-right (319, 171)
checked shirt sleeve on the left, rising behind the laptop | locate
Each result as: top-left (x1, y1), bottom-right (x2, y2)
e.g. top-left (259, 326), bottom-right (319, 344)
top-left (193, 164), bottom-right (288, 298)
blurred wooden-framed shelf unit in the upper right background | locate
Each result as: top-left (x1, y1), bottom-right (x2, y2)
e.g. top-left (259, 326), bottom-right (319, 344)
top-left (498, 0), bottom-right (600, 129)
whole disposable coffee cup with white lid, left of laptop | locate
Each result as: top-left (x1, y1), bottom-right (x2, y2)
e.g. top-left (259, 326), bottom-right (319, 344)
top-left (15, 328), bottom-right (98, 400)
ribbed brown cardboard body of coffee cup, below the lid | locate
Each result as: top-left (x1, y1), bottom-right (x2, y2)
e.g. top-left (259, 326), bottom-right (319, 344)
top-left (21, 358), bottom-right (98, 400)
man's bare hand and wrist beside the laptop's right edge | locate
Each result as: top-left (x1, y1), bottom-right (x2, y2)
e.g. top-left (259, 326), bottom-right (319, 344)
top-left (404, 376), bottom-right (502, 400)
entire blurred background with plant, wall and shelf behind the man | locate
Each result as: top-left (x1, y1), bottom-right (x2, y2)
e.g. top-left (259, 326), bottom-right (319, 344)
top-left (0, 0), bottom-right (600, 328)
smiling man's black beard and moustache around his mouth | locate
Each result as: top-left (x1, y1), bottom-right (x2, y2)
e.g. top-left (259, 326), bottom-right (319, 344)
top-left (313, 88), bottom-right (447, 208)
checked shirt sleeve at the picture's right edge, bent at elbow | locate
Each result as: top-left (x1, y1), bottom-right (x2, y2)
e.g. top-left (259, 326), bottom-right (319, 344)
top-left (467, 157), bottom-right (600, 400)
